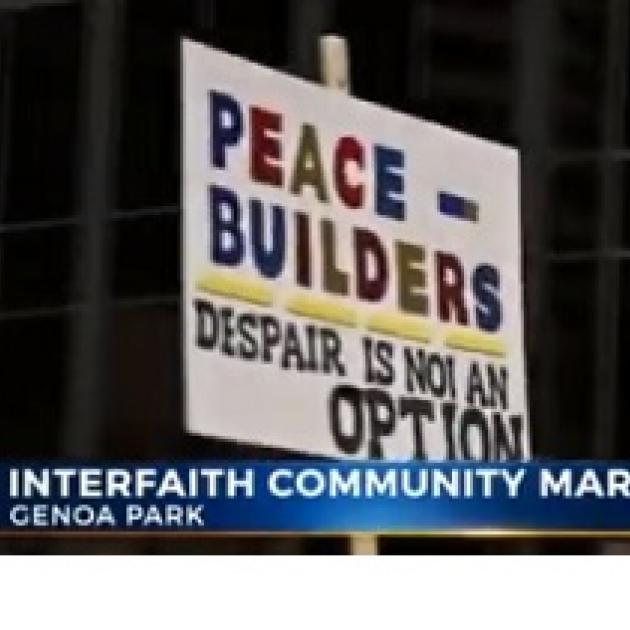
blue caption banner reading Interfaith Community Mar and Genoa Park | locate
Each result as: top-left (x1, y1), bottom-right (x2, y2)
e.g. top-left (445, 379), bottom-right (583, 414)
top-left (0, 461), bottom-right (630, 534)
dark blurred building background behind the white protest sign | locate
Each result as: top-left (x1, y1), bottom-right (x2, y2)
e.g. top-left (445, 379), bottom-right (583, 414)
top-left (0, 0), bottom-right (630, 552)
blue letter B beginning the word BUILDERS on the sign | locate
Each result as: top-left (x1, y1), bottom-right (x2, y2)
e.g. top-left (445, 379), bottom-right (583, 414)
top-left (209, 186), bottom-right (244, 267)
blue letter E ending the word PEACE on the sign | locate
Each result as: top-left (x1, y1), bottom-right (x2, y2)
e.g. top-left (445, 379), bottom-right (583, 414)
top-left (374, 144), bottom-right (405, 221)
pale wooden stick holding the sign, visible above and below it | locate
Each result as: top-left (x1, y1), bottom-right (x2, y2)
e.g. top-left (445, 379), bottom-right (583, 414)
top-left (319, 35), bottom-right (378, 555)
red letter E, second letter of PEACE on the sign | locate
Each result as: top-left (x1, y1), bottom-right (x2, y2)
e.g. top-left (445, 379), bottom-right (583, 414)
top-left (250, 107), bottom-right (282, 186)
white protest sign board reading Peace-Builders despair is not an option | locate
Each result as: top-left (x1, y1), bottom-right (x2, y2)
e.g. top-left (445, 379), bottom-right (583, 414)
top-left (182, 41), bottom-right (529, 459)
